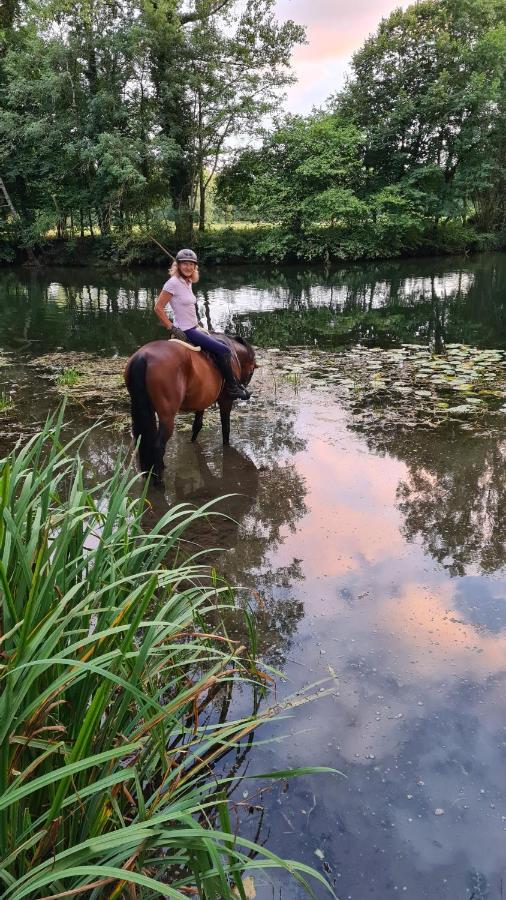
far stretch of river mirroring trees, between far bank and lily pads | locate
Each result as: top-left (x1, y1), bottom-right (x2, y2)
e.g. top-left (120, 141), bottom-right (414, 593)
top-left (0, 253), bottom-right (506, 354)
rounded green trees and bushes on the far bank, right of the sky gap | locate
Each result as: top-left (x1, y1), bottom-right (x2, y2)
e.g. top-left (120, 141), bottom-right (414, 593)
top-left (217, 0), bottom-right (506, 259)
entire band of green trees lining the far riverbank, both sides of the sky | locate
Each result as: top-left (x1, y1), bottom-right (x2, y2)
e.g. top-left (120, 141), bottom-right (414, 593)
top-left (0, 0), bottom-right (506, 263)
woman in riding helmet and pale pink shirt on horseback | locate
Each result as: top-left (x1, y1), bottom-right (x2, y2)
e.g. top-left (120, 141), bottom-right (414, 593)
top-left (155, 250), bottom-right (250, 400)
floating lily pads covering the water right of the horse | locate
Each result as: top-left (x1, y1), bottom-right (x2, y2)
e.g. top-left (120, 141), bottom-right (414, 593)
top-left (269, 344), bottom-right (506, 431)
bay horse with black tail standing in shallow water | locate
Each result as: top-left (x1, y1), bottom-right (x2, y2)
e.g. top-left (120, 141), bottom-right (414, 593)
top-left (124, 333), bottom-right (256, 478)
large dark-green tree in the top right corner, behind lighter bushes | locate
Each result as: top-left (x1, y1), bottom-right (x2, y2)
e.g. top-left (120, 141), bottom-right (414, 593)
top-left (335, 0), bottom-right (506, 219)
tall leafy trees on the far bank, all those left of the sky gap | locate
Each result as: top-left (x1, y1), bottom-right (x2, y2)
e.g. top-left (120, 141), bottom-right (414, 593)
top-left (0, 0), bottom-right (303, 243)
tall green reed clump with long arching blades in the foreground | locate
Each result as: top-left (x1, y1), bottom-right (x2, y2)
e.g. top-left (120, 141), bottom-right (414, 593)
top-left (0, 413), bottom-right (332, 900)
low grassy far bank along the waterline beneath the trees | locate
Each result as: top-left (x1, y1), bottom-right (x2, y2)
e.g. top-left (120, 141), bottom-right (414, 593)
top-left (0, 221), bottom-right (506, 266)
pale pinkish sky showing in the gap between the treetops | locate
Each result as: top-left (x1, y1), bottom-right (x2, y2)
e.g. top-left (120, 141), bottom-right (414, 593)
top-left (276, 0), bottom-right (412, 115)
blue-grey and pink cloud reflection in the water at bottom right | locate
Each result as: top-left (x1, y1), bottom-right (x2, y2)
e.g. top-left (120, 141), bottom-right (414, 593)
top-left (274, 552), bottom-right (506, 898)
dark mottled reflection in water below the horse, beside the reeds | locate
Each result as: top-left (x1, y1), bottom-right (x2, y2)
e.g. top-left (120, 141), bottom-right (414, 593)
top-left (140, 409), bottom-right (306, 663)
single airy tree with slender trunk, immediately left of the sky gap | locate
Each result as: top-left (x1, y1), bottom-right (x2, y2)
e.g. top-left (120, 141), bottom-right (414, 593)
top-left (140, 0), bottom-right (304, 243)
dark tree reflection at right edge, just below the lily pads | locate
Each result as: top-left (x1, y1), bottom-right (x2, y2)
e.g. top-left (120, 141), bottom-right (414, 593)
top-left (354, 420), bottom-right (506, 575)
